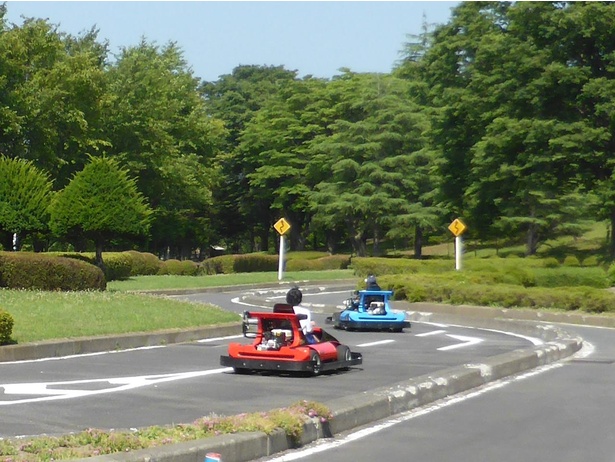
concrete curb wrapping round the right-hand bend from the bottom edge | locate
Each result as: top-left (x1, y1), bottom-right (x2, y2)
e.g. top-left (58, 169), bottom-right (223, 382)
top-left (71, 303), bottom-right (583, 462)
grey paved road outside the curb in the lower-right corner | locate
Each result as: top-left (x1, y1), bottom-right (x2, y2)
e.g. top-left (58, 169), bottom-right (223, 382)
top-left (263, 325), bottom-right (615, 462)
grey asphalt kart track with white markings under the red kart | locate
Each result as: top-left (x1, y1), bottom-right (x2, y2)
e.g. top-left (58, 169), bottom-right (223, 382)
top-left (0, 291), bottom-right (530, 437)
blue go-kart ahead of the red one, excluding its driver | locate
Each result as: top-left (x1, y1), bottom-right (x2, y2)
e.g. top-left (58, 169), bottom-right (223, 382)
top-left (327, 290), bottom-right (410, 332)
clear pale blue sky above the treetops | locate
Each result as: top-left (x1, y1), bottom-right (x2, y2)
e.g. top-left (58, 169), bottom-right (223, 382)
top-left (6, 0), bottom-right (459, 81)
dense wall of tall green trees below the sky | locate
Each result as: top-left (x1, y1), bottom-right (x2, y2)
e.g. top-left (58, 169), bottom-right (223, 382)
top-left (0, 2), bottom-right (615, 258)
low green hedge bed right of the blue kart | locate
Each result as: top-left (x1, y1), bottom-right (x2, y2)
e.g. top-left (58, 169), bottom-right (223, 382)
top-left (352, 258), bottom-right (615, 313)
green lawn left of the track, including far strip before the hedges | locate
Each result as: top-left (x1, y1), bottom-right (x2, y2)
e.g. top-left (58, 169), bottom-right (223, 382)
top-left (0, 270), bottom-right (354, 344)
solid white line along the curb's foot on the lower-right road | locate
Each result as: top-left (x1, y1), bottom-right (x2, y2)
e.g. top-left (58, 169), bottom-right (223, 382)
top-left (266, 342), bottom-right (594, 462)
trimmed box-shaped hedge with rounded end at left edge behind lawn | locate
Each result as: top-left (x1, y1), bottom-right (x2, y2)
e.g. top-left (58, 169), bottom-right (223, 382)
top-left (0, 252), bottom-right (107, 291)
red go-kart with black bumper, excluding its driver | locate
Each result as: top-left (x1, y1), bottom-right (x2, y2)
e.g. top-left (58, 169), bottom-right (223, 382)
top-left (220, 304), bottom-right (363, 375)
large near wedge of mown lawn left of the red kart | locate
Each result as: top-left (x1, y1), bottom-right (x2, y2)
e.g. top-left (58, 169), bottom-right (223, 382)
top-left (0, 289), bottom-right (239, 343)
